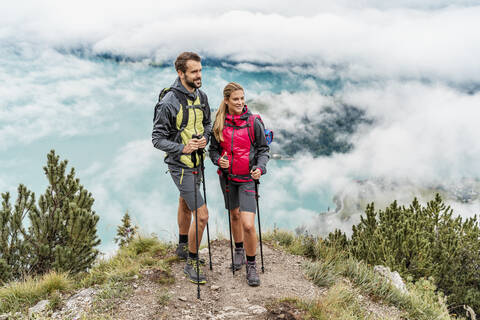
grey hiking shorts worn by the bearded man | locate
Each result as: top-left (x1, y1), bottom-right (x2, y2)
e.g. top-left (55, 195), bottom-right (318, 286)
top-left (168, 166), bottom-right (205, 211)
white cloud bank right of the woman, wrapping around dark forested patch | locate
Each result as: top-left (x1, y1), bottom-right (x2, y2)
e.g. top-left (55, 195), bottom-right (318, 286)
top-left (257, 82), bottom-right (480, 189)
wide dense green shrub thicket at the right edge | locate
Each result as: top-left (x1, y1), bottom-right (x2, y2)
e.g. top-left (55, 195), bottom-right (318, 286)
top-left (338, 194), bottom-right (480, 313)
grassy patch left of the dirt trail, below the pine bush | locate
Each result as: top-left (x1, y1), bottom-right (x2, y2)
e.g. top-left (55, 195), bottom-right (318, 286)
top-left (0, 237), bottom-right (177, 319)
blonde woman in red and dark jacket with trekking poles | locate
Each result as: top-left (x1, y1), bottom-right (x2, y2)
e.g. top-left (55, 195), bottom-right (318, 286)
top-left (209, 82), bottom-right (269, 286)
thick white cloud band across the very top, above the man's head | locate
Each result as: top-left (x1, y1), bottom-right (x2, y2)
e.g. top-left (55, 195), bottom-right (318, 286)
top-left (0, 1), bottom-right (480, 83)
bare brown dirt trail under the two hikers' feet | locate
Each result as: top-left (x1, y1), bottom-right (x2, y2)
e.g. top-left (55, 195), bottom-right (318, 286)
top-left (117, 240), bottom-right (324, 319)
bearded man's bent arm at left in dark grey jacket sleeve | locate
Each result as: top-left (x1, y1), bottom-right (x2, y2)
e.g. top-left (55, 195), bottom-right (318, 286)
top-left (152, 102), bottom-right (184, 155)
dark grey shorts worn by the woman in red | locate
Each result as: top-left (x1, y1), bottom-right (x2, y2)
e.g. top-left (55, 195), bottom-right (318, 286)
top-left (219, 175), bottom-right (257, 213)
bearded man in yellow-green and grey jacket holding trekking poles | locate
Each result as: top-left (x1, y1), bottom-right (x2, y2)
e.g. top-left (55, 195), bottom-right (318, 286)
top-left (152, 52), bottom-right (211, 283)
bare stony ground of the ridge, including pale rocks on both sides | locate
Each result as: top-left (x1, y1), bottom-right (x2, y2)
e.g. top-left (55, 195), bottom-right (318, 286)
top-left (21, 240), bottom-right (401, 320)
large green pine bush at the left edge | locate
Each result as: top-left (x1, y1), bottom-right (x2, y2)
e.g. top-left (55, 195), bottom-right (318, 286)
top-left (0, 150), bottom-right (100, 282)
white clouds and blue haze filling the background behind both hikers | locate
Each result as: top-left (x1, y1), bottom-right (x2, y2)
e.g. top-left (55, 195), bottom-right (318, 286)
top-left (0, 0), bottom-right (480, 250)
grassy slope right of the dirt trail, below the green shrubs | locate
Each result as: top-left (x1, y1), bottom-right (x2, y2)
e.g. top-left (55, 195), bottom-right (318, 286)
top-left (264, 230), bottom-right (461, 320)
